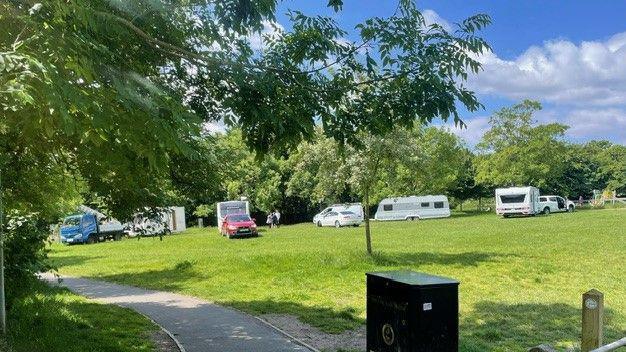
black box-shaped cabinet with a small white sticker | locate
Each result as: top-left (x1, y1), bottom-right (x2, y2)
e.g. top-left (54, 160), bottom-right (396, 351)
top-left (367, 271), bottom-right (459, 352)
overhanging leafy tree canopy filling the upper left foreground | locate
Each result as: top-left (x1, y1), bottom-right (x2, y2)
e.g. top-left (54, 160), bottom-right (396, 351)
top-left (0, 0), bottom-right (490, 217)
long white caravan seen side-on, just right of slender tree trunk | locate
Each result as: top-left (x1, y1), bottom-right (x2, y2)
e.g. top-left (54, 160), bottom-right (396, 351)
top-left (374, 195), bottom-right (450, 221)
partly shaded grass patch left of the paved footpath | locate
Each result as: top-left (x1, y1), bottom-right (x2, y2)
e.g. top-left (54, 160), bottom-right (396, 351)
top-left (0, 283), bottom-right (157, 352)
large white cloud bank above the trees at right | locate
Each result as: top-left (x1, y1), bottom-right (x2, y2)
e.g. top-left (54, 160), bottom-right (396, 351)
top-left (469, 32), bottom-right (626, 106)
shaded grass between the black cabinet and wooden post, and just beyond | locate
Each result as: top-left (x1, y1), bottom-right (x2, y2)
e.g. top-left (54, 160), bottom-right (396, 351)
top-left (460, 301), bottom-right (626, 352)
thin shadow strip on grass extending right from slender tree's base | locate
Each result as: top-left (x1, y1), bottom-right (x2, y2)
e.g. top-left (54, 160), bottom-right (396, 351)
top-left (366, 252), bottom-right (514, 266)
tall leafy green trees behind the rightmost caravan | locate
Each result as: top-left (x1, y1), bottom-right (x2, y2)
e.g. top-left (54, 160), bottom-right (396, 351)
top-left (475, 100), bottom-right (626, 198)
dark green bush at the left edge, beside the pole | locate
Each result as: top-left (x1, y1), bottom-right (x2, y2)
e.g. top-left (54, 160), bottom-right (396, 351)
top-left (4, 211), bottom-right (52, 307)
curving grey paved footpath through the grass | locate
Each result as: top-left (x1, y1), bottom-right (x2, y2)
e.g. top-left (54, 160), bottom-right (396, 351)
top-left (41, 273), bottom-right (310, 352)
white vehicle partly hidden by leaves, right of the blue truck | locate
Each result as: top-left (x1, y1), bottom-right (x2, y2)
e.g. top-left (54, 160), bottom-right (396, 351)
top-left (128, 207), bottom-right (187, 237)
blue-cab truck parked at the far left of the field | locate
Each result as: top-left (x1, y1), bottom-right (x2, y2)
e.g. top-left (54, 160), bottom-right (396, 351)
top-left (60, 206), bottom-right (124, 244)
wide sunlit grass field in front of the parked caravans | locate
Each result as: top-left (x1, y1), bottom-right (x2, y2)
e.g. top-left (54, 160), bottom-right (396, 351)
top-left (52, 209), bottom-right (626, 351)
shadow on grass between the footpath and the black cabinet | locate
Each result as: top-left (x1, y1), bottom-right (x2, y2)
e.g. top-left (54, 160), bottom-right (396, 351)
top-left (223, 300), bottom-right (365, 334)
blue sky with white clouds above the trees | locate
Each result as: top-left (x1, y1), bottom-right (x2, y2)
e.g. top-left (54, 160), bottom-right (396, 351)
top-left (270, 0), bottom-right (626, 144)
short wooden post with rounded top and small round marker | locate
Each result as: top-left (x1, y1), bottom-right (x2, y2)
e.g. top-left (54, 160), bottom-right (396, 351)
top-left (580, 289), bottom-right (604, 352)
